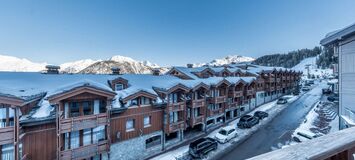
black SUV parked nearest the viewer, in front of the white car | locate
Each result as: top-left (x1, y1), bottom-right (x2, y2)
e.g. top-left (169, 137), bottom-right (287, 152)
top-left (189, 137), bottom-right (218, 158)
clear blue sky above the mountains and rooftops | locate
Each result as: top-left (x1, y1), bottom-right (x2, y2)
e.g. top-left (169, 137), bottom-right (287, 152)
top-left (0, 0), bottom-right (355, 65)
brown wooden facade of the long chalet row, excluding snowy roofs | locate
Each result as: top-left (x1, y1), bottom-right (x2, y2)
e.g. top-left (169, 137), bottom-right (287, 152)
top-left (0, 64), bottom-right (300, 160)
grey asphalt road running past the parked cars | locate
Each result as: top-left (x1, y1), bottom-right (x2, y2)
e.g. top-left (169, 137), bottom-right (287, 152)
top-left (223, 83), bottom-right (325, 160)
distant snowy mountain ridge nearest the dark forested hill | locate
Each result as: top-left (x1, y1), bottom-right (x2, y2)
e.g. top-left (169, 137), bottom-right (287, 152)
top-left (193, 55), bottom-right (255, 67)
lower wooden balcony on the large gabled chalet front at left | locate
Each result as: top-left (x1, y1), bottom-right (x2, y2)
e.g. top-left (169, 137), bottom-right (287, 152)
top-left (60, 140), bottom-right (110, 160)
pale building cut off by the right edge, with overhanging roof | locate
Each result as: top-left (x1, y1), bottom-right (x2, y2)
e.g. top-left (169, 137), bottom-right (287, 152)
top-left (320, 24), bottom-right (355, 129)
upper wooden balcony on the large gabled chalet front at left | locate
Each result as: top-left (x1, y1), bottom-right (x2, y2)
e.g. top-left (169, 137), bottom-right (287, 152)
top-left (59, 113), bottom-right (108, 133)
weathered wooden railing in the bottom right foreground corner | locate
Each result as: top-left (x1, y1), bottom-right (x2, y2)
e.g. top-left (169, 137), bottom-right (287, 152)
top-left (251, 127), bottom-right (355, 160)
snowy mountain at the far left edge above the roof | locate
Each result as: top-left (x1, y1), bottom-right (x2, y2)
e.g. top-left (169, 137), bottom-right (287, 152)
top-left (0, 55), bottom-right (47, 72)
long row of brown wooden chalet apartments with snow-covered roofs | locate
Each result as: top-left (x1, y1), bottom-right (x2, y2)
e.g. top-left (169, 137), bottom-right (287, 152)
top-left (0, 64), bottom-right (302, 160)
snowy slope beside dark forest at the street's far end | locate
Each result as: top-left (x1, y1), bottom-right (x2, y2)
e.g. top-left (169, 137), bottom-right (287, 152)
top-left (292, 56), bottom-right (333, 78)
